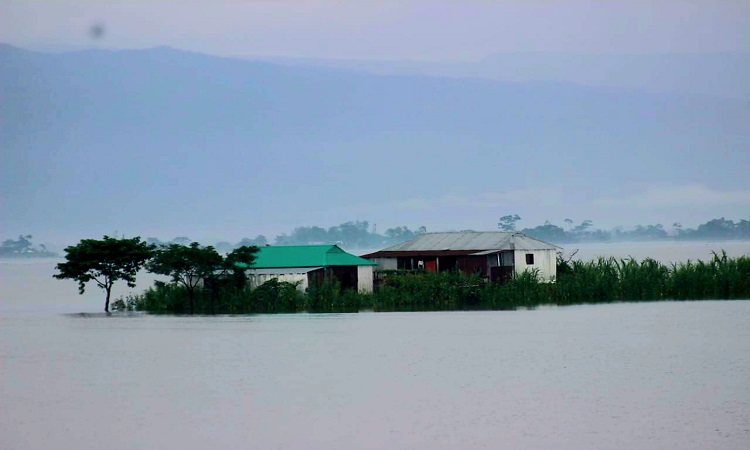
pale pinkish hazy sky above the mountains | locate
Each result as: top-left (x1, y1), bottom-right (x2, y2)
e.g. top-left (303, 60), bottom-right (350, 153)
top-left (0, 0), bottom-right (750, 60)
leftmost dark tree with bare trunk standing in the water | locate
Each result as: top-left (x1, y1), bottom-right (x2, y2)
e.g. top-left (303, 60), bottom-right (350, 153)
top-left (53, 236), bottom-right (154, 312)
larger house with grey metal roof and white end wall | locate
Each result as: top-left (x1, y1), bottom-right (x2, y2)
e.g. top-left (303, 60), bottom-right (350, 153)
top-left (363, 231), bottom-right (561, 281)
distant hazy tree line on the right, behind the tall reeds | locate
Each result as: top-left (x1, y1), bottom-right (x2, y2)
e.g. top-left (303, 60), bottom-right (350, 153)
top-left (498, 214), bottom-right (750, 244)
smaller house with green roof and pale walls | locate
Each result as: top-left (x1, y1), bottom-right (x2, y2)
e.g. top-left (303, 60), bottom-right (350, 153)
top-left (247, 245), bottom-right (376, 292)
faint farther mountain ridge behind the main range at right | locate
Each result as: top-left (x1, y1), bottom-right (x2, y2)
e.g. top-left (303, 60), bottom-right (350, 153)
top-left (248, 52), bottom-right (750, 99)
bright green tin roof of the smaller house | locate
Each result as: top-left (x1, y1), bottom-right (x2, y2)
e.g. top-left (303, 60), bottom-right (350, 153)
top-left (245, 245), bottom-right (377, 269)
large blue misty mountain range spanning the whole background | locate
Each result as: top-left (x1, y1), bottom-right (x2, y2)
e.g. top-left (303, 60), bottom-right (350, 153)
top-left (0, 45), bottom-right (750, 243)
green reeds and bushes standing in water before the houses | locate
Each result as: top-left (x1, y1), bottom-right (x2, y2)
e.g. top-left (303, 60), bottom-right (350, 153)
top-left (123, 252), bottom-right (750, 314)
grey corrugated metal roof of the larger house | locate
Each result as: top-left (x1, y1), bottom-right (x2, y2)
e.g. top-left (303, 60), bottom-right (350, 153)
top-left (377, 231), bottom-right (560, 253)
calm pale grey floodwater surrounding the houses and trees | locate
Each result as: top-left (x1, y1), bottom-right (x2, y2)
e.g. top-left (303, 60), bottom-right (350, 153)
top-left (0, 241), bottom-right (750, 449)
